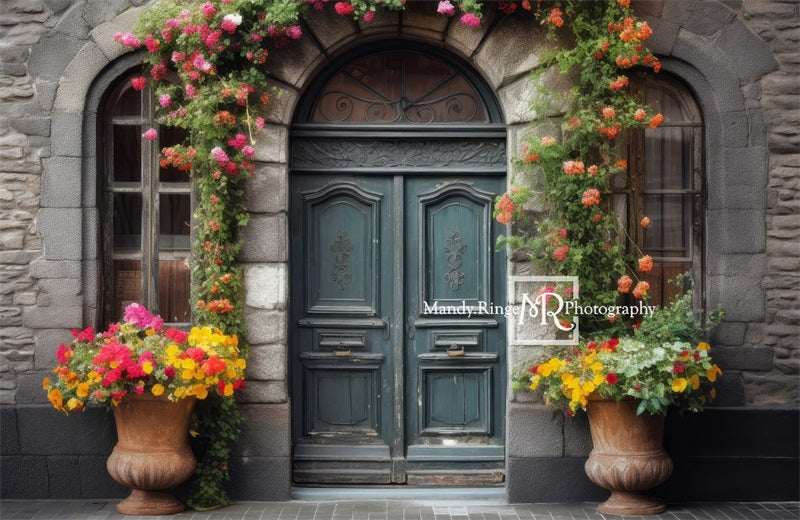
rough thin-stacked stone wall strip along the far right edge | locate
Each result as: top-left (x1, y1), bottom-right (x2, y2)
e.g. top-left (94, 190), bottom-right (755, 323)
top-left (738, 0), bottom-right (800, 404)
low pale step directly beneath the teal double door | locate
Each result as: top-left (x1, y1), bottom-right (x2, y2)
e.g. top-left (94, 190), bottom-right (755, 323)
top-left (292, 486), bottom-right (506, 505)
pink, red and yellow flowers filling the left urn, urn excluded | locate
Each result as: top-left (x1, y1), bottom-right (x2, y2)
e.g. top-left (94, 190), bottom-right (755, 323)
top-left (43, 303), bottom-right (247, 414)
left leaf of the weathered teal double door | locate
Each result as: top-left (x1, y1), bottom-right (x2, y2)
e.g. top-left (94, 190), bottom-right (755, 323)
top-left (290, 175), bottom-right (395, 484)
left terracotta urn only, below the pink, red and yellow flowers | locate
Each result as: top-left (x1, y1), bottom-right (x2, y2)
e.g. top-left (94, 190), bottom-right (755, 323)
top-left (106, 392), bottom-right (197, 515)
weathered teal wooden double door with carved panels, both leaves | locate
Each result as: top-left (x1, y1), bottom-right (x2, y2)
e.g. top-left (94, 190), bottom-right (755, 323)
top-left (290, 171), bottom-right (506, 485)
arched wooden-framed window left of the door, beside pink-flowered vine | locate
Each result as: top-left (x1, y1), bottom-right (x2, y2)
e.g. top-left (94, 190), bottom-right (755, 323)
top-left (97, 69), bottom-right (191, 323)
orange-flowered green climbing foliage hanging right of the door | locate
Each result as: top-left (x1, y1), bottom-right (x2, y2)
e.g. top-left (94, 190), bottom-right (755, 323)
top-left (498, 0), bottom-right (660, 333)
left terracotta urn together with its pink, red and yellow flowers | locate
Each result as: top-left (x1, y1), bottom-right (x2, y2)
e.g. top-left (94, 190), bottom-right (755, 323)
top-left (43, 303), bottom-right (247, 515)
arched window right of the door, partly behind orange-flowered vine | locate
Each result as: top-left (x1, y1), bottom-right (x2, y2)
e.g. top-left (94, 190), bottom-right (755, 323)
top-left (621, 73), bottom-right (704, 304)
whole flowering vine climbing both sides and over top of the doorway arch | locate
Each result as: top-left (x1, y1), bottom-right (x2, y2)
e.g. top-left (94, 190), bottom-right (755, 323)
top-left (115, 0), bottom-right (658, 509)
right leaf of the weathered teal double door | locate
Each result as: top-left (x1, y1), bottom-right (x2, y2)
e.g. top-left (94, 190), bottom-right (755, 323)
top-left (405, 177), bottom-right (505, 464)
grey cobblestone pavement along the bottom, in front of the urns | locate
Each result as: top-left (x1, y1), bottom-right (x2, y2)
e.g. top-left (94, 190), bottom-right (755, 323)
top-left (0, 500), bottom-right (800, 520)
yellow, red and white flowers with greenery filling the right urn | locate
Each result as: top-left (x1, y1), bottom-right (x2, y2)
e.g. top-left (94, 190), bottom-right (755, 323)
top-left (515, 291), bottom-right (722, 415)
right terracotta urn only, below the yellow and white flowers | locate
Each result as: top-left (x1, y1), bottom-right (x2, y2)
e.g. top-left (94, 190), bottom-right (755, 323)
top-left (585, 396), bottom-right (673, 515)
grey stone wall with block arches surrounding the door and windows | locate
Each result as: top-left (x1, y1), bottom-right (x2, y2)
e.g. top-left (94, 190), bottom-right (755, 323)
top-left (0, 0), bottom-right (800, 500)
